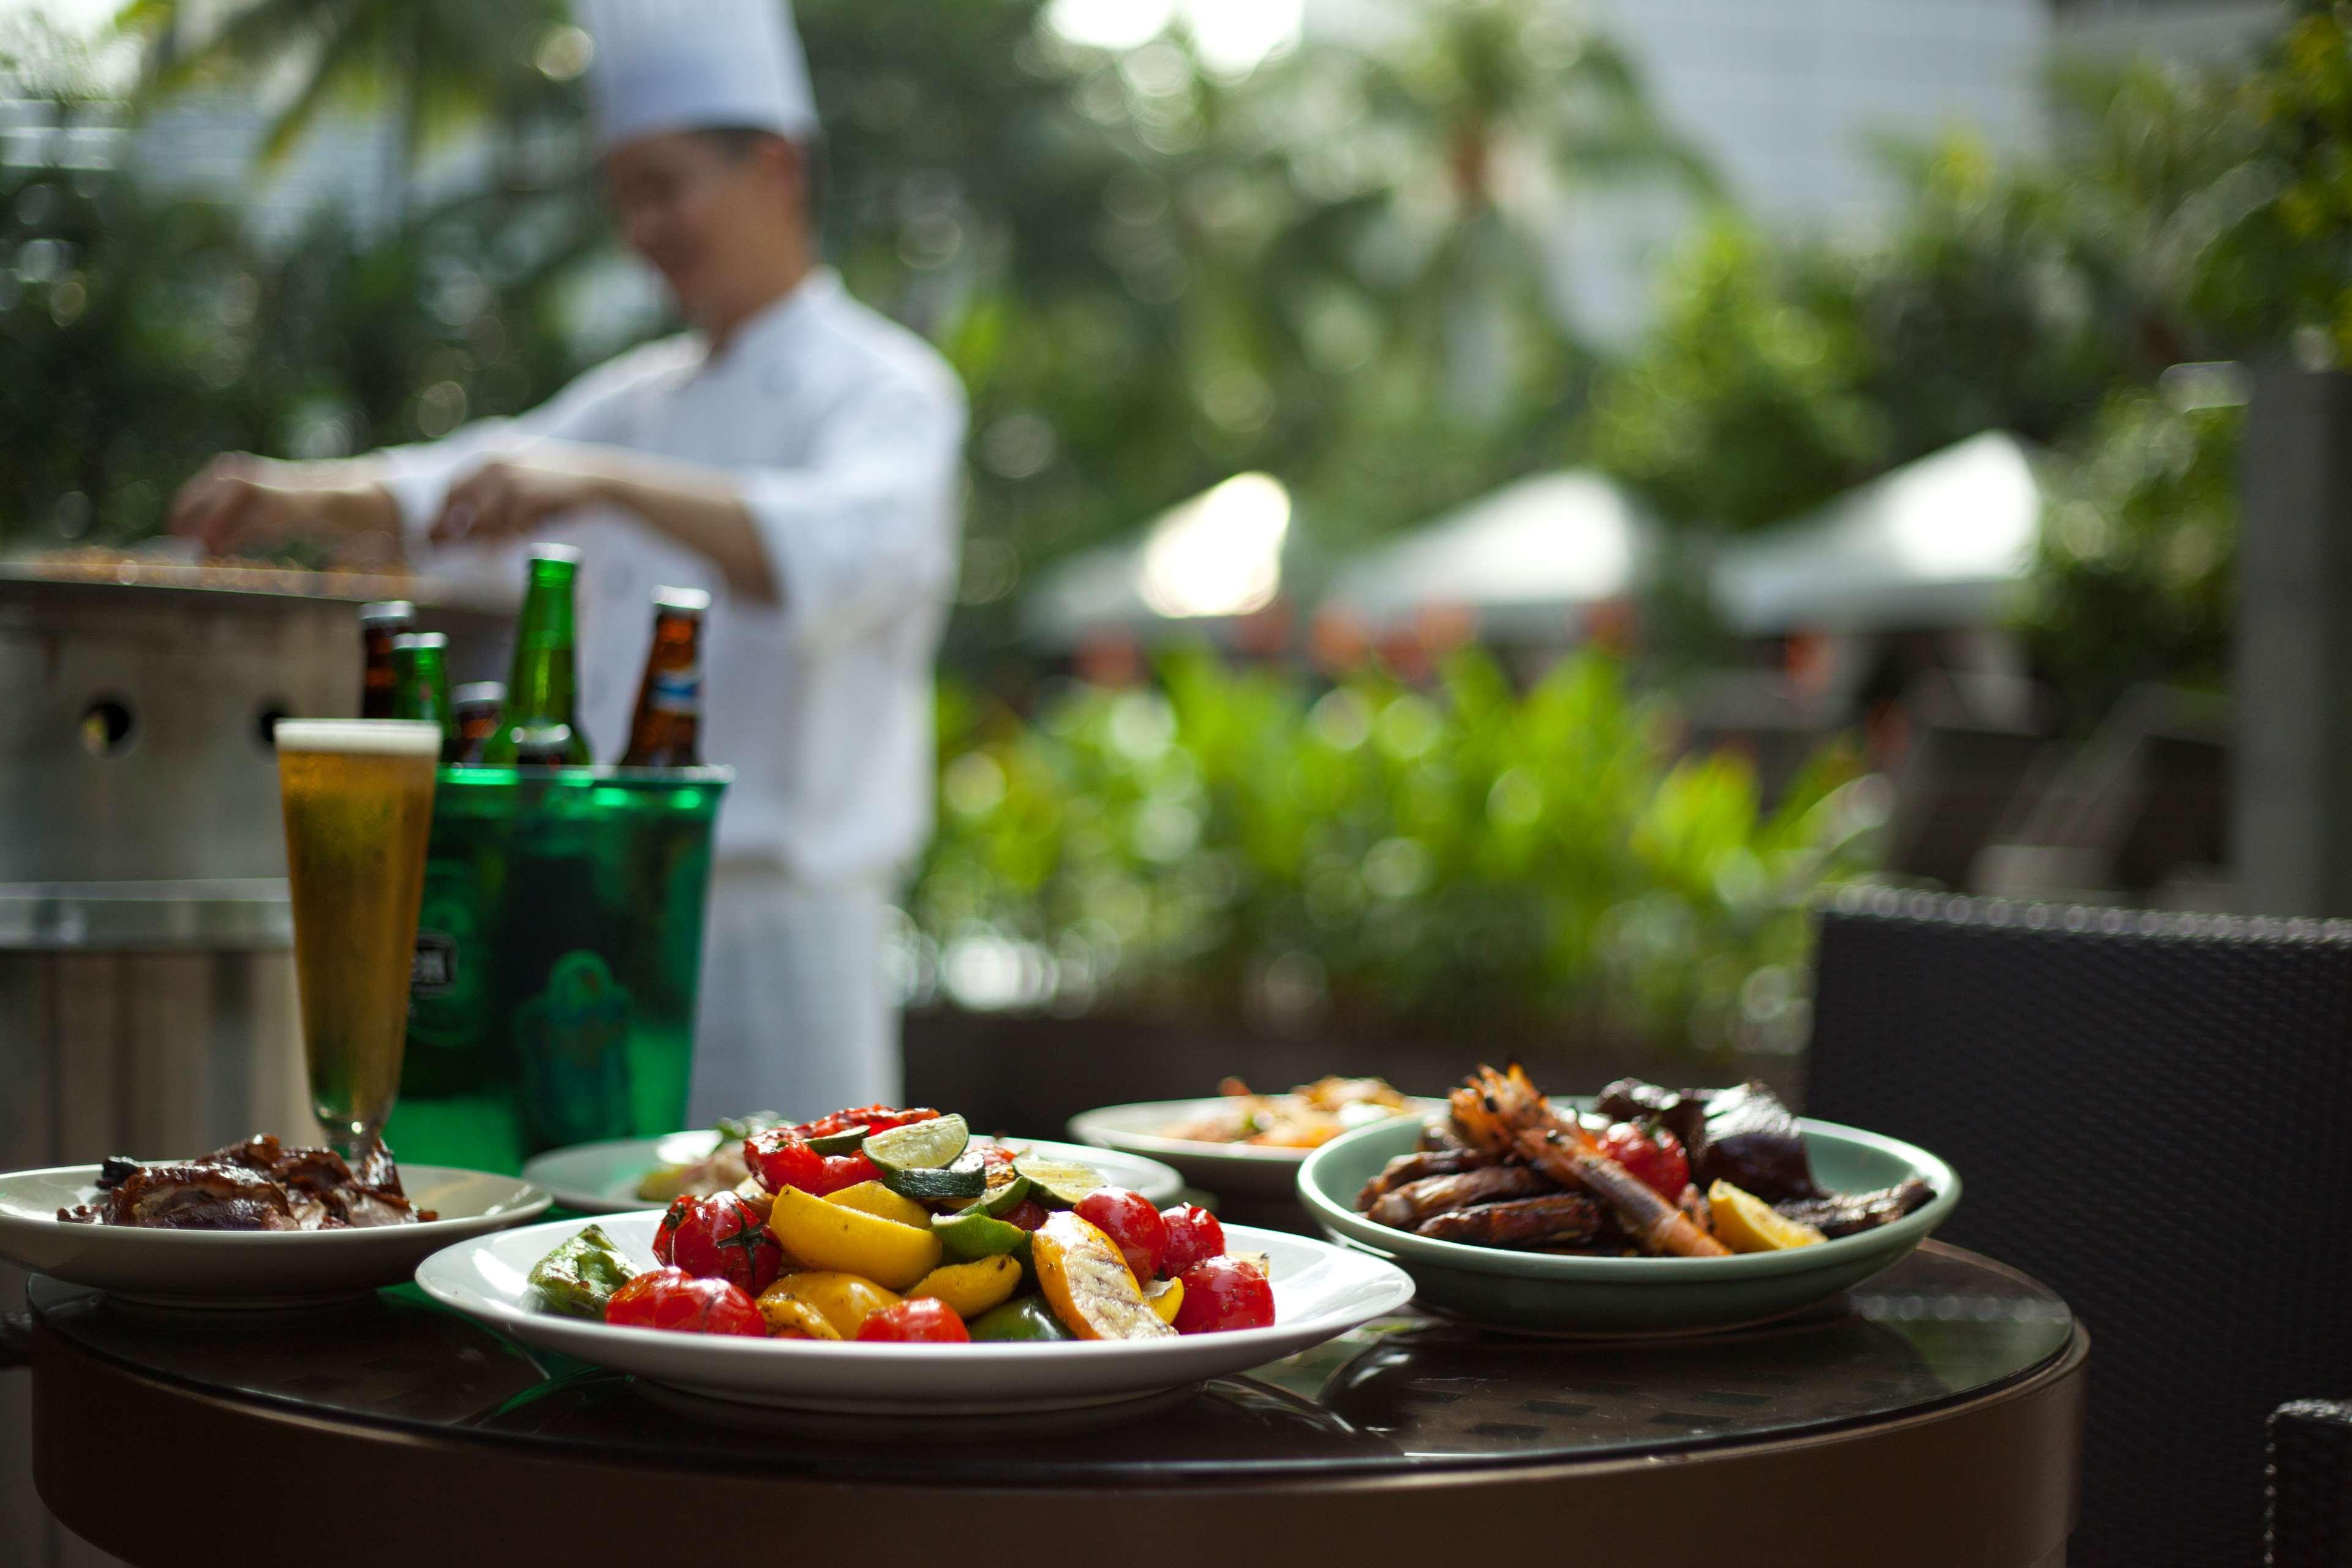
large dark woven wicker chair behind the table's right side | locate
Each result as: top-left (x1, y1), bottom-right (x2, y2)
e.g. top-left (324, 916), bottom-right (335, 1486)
top-left (1806, 891), bottom-right (2352, 1568)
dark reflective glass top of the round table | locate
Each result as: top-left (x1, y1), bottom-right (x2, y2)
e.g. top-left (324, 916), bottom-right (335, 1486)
top-left (31, 1243), bottom-right (2075, 1486)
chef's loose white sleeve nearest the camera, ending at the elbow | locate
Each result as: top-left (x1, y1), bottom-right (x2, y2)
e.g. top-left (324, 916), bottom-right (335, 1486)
top-left (739, 379), bottom-right (967, 649)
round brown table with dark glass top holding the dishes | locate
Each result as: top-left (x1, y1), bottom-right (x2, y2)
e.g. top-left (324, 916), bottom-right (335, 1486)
top-left (31, 1243), bottom-right (2089, 1568)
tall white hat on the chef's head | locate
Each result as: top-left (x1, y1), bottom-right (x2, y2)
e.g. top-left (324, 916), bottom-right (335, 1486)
top-left (576, 0), bottom-right (816, 153)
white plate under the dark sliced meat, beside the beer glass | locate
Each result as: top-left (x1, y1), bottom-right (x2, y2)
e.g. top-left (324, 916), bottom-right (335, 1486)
top-left (0, 1164), bottom-right (551, 1307)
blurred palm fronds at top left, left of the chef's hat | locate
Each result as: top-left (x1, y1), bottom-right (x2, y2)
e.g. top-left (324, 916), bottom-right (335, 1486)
top-left (118, 0), bottom-right (583, 211)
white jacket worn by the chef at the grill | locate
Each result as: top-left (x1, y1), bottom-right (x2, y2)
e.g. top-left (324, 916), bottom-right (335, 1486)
top-left (381, 268), bottom-right (967, 884)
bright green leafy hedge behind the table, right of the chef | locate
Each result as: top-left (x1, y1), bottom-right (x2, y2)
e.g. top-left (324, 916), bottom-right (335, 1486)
top-left (913, 654), bottom-right (1872, 1046)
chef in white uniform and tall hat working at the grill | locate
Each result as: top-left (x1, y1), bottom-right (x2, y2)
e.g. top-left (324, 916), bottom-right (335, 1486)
top-left (172, 0), bottom-right (964, 1121)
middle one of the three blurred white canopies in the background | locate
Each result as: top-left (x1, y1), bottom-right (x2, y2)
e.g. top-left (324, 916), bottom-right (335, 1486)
top-left (1327, 470), bottom-right (1651, 637)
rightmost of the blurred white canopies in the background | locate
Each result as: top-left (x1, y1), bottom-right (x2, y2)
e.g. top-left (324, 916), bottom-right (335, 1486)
top-left (1714, 430), bottom-right (2041, 637)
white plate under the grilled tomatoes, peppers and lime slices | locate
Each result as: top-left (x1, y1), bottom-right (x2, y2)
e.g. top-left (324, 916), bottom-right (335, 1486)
top-left (417, 1213), bottom-right (1414, 1415)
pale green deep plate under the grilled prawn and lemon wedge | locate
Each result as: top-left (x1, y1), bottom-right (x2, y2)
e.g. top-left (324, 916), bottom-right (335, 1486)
top-left (1298, 1119), bottom-right (1959, 1335)
